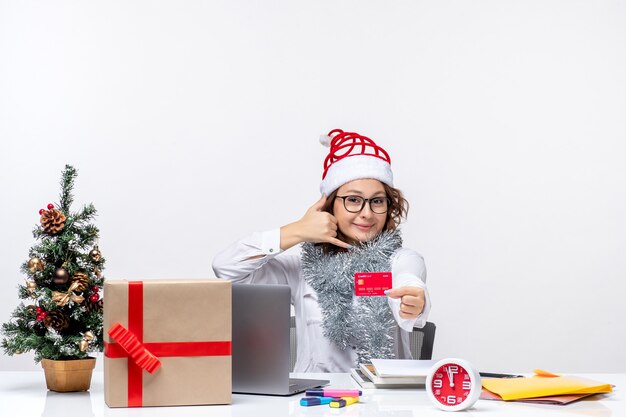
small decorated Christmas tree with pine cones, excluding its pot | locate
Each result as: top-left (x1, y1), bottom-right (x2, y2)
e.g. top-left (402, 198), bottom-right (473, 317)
top-left (2, 165), bottom-right (105, 362)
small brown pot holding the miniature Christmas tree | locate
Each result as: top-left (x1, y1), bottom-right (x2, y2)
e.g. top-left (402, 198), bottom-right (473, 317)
top-left (41, 358), bottom-right (96, 392)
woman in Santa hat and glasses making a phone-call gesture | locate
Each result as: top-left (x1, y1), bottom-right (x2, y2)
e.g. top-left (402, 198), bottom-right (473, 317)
top-left (213, 129), bottom-right (430, 372)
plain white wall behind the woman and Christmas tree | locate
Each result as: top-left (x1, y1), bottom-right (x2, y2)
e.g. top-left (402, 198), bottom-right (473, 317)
top-left (0, 0), bottom-right (626, 372)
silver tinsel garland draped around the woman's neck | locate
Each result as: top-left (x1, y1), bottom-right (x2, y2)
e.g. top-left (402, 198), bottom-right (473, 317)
top-left (302, 231), bottom-right (402, 363)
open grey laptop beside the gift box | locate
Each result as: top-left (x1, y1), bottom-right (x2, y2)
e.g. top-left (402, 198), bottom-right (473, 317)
top-left (232, 284), bottom-right (329, 395)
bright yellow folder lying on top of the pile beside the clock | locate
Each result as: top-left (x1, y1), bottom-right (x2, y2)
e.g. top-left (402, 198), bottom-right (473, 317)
top-left (482, 372), bottom-right (612, 401)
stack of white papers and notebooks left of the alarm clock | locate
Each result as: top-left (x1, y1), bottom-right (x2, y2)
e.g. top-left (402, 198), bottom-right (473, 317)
top-left (351, 359), bottom-right (435, 389)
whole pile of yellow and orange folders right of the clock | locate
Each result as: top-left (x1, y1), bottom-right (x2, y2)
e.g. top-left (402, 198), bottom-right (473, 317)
top-left (481, 370), bottom-right (612, 404)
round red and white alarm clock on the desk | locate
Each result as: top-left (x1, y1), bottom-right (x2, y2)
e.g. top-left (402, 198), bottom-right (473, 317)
top-left (426, 358), bottom-right (482, 411)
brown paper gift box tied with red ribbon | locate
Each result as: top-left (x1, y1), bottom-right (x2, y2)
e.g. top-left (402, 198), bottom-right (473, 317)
top-left (104, 279), bottom-right (232, 407)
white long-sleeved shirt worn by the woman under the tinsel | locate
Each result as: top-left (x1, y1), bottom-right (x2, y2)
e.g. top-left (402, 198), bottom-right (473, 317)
top-left (213, 229), bottom-right (430, 372)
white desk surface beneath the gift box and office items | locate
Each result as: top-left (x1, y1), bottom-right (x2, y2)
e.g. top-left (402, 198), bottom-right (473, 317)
top-left (0, 372), bottom-right (626, 417)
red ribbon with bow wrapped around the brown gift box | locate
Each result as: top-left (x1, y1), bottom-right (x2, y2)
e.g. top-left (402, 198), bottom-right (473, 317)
top-left (104, 281), bottom-right (232, 407)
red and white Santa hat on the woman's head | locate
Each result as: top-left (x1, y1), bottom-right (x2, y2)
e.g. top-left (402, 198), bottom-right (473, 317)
top-left (320, 129), bottom-right (393, 196)
